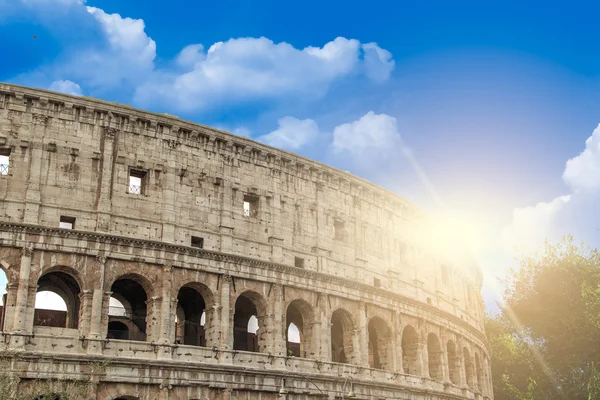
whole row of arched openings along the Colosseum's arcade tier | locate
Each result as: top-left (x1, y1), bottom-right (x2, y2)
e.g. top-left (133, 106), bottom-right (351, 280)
top-left (0, 269), bottom-right (483, 390)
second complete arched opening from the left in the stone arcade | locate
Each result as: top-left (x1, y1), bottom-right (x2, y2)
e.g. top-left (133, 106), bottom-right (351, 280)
top-left (107, 276), bottom-right (148, 341)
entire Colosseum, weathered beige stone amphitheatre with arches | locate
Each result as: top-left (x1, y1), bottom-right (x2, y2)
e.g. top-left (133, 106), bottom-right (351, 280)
top-left (0, 84), bottom-right (493, 400)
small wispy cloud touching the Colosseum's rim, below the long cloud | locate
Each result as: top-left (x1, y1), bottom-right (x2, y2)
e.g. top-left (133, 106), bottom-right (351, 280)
top-left (257, 117), bottom-right (319, 150)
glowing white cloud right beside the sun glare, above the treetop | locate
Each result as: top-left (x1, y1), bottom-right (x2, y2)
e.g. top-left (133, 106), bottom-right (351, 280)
top-left (502, 195), bottom-right (571, 253)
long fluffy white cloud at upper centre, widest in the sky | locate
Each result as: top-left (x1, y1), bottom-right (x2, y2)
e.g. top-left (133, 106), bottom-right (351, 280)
top-left (135, 37), bottom-right (393, 111)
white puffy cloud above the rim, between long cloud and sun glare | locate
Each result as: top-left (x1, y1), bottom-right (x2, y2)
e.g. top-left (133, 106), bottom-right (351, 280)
top-left (332, 111), bottom-right (403, 156)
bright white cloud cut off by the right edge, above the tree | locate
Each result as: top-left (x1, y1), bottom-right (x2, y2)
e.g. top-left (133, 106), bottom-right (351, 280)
top-left (563, 125), bottom-right (600, 191)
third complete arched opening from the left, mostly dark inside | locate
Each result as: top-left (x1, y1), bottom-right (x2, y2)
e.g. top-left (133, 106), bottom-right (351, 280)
top-left (175, 286), bottom-right (206, 346)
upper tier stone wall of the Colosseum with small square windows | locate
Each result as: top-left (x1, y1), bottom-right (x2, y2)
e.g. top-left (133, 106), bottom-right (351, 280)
top-left (0, 84), bottom-right (483, 327)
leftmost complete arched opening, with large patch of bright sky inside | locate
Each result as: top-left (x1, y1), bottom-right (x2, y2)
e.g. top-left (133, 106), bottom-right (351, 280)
top-left (33, 271), bottom-right (80, 329)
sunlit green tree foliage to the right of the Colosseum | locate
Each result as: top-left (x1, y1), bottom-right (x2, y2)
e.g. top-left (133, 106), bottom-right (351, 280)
top-left (486, 237), bottom-right (600, 400)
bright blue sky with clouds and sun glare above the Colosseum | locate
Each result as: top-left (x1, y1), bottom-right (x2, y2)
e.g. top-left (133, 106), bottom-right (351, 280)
top-left (0, 0), bottom-right (600, 308)
